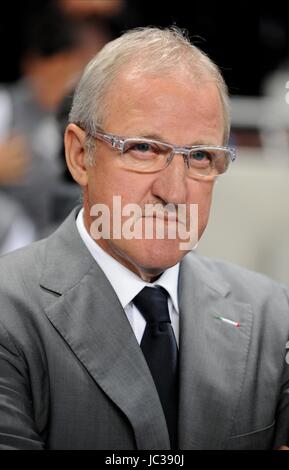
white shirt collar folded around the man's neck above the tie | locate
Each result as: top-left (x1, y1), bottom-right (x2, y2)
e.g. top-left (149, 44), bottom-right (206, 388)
top-left (76, 208), bottom-right (180, 313)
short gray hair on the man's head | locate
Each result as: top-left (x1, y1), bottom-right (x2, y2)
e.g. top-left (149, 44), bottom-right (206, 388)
top-left (69, 26), bottom-right (230, 163)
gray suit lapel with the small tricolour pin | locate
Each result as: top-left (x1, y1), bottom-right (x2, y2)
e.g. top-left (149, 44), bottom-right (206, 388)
top-left (179, 255), bottom-right (252, 449)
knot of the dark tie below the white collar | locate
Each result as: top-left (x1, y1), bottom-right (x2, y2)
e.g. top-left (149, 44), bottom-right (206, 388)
top-left (133, 287), bottom-right (171, 323)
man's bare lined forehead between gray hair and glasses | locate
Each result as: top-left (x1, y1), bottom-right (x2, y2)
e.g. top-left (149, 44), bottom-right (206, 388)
top-left (104, 70), bottom-right (224, 144)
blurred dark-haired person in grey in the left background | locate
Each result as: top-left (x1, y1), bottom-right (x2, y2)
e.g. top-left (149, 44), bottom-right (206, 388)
top-left (0, 4), bottom-right (89, 237)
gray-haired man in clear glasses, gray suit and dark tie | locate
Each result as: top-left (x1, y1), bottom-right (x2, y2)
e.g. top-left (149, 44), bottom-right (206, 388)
top-left (0, 28), bottom-right (289, 449)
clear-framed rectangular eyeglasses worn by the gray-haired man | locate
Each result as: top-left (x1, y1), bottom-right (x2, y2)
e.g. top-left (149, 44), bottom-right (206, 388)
top-left (86, 131), bottom-right (236, 179)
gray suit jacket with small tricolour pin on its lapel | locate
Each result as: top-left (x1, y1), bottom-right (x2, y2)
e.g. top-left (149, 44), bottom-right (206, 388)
top-left (0, 210), bottom-right (289, 450)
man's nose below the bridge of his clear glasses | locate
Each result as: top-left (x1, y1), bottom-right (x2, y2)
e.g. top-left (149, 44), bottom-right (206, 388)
top-left (152, 152), bottom-right (188, 204)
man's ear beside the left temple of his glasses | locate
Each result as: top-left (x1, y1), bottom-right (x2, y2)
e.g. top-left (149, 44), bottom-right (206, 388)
top-left (64, 124), bottom-right (88, 187)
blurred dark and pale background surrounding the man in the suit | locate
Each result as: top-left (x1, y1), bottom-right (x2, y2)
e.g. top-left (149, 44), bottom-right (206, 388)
top-left (0, 0), bottom-right (289, 284)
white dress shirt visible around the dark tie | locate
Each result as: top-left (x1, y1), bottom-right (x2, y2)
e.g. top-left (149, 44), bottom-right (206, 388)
top-left (76, 209), bottom-right (180, 344)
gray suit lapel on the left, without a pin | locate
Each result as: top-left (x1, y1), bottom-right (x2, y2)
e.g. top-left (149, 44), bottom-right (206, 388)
top-left (41, 208), bottom-right (169, 449)
